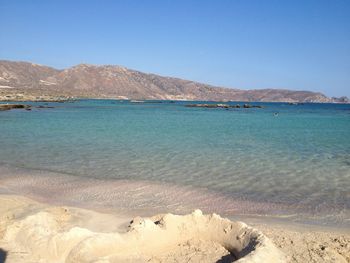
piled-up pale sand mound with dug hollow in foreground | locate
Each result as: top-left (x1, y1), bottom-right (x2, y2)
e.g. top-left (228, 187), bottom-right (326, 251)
top-left (3, 198), bottom-right (284, 262)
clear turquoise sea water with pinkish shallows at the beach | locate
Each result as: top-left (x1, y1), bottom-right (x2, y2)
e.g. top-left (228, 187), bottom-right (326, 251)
top-left (0, 100), bottom-right (350, 228)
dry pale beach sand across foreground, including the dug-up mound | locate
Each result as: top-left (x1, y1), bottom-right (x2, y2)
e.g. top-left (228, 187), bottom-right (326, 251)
top-left (0, 195), bottom-right (350, 262)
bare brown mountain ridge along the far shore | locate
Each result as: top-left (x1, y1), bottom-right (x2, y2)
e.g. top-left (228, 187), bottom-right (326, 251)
top-left (0, 60), bottom-right (333, 102)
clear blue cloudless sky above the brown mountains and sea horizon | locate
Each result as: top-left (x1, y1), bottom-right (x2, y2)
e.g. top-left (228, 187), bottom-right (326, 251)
top-left (0, 0), bottom-right (350, 96)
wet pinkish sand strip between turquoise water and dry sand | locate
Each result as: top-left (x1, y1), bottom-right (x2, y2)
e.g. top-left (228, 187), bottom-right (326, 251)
top-left (0, 164), bottom-right (350, 234)
